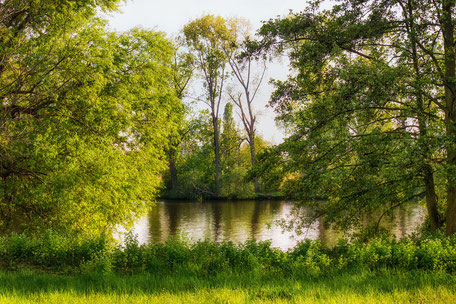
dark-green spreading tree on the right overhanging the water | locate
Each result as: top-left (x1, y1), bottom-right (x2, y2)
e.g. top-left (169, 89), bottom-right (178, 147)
top-left (255, 0), bottom-right (456, 234)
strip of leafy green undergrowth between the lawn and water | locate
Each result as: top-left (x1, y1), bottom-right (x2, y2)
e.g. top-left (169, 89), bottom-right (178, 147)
top-left (0, 231), bottom-right (456, 277)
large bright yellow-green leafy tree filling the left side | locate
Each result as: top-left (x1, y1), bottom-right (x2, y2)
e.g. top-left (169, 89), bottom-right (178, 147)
top-left (0, 0), bottom-right (182, 233)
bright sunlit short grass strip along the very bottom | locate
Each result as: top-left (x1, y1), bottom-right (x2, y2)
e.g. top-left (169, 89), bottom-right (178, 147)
top-left (0, 269), bottom-right (456, 304)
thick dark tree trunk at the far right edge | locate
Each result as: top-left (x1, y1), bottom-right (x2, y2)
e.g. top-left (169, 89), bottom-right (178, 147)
top-left (440, 0), bottom-right (456, 235)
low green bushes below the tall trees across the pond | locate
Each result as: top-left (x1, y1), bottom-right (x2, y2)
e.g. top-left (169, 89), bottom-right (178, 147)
top-left (160, 103), bottom-right (281, 200)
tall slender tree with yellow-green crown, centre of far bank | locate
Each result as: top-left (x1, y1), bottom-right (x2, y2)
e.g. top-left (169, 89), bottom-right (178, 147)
top-left (184, 15), bottom-right (234, 194)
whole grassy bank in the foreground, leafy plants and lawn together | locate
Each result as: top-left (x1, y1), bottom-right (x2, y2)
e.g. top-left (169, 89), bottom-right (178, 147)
top-left (0, 232), bottom-right (456, 303)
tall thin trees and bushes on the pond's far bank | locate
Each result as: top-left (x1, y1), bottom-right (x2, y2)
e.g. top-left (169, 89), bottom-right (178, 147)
top-left (161, 15), bottom-right (280, 199)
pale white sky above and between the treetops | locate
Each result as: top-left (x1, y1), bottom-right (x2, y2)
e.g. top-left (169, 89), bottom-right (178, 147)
top-left (107, 0), bottom-right (312, 144)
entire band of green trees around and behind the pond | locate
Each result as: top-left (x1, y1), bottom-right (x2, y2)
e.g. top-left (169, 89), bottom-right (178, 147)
top-left (0, 0), bottom-right (456, 240)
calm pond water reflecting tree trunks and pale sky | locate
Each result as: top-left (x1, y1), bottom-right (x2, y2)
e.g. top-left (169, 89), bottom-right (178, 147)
top-left (129, 201), bottom-right (424, 250)
